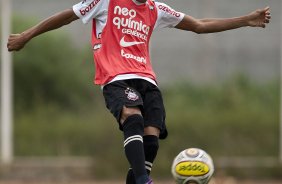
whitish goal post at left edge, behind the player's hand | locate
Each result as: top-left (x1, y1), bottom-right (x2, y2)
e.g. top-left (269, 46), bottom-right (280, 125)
top-left (0, 0), bottom-right (13, 164)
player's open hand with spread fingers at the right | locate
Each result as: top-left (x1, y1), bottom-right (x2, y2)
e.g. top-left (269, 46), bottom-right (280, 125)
top-left (248, 7), bottom-right (271, 28)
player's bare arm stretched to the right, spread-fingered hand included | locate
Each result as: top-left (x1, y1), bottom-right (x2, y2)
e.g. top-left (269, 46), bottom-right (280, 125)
top-left (176, 7), bottom-right (271, 34)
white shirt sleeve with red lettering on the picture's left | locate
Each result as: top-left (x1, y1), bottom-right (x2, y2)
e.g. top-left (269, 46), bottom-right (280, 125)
top-left (72, 0), bottom-right (109, 24)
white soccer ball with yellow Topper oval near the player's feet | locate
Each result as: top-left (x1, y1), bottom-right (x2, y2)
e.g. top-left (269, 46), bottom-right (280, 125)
top-left (171, 148), bottom-right (214, 184)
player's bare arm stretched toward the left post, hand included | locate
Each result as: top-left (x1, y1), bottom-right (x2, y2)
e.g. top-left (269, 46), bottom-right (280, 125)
top-left (7, 9), bottom-right (78, 51)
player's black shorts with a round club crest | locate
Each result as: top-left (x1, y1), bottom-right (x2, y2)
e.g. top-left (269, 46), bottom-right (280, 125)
top-left (103, 79), bottom-right (168, 139)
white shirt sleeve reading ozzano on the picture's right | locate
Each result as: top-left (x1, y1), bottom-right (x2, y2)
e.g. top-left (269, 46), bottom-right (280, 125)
top-left (155, 2), bottom-right (185, 29)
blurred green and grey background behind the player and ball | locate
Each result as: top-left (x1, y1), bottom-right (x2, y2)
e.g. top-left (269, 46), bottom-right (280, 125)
top-left (0, 0), bottom-right (282, 184)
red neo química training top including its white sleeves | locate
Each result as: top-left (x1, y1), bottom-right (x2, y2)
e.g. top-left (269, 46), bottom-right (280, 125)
top-left (73, 0), bottom-right (184, 85)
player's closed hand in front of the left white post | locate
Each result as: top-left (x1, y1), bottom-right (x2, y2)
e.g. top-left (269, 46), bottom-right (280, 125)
top-left (7, 33), bottom-right (28, 51)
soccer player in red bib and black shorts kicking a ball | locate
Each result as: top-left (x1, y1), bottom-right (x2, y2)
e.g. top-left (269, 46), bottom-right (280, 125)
top-left (7, 0), bottom-right (271, 184)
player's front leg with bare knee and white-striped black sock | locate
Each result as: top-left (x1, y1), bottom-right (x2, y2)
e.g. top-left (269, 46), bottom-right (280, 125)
top-left (121, 108), bottom-right (149, 184)
